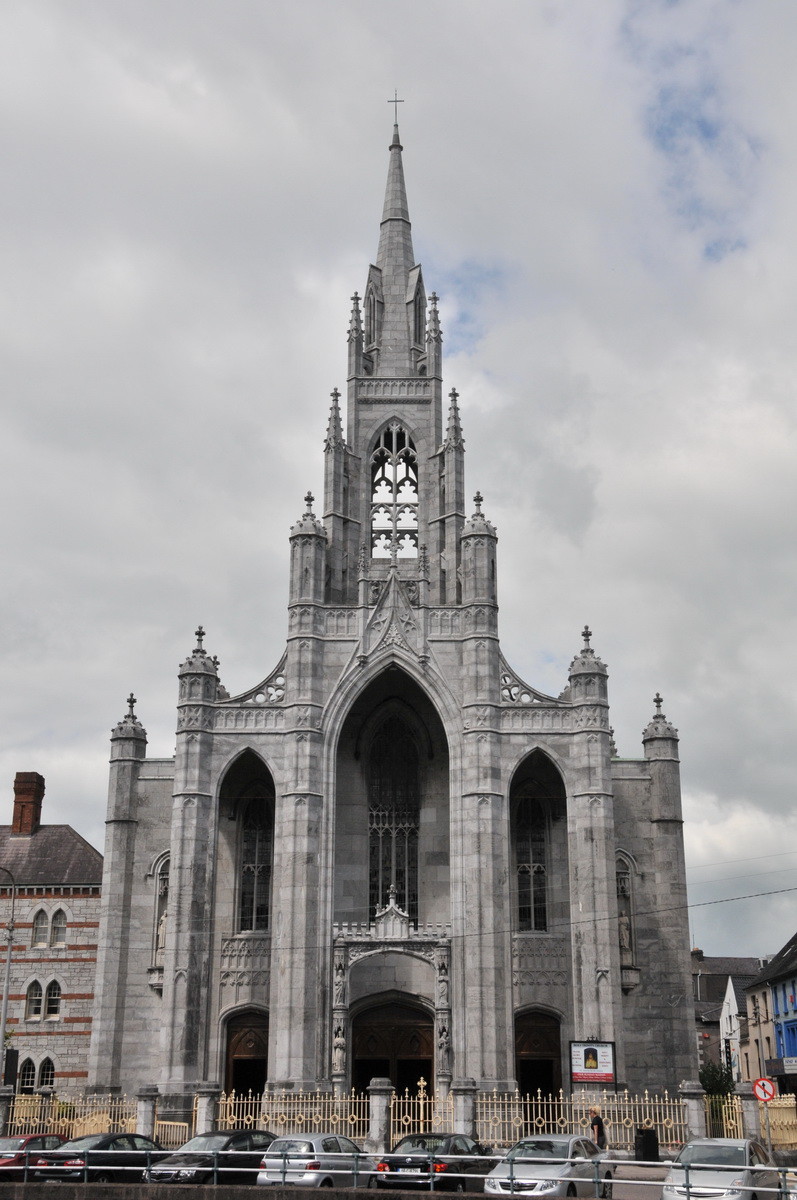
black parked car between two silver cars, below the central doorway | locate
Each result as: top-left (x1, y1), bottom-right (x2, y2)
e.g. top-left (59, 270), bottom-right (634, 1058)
top-left (377, 1133), bottom-right (498, 1192)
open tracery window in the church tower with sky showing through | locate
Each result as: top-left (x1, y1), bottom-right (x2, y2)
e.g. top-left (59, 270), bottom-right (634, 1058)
top-left (371, 421), bottom-right (418, 558)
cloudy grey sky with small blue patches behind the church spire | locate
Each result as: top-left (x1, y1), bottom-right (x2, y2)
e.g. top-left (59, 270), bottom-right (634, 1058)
top-left (0, 0), bottom-right (797, 955)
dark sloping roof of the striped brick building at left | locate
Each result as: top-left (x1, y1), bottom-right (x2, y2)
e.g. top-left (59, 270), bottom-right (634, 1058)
top-left (0, 826), bottom-right (102, 888)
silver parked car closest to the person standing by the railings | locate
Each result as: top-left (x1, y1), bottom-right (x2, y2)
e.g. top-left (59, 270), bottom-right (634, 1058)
top-left (484, 1134), bottom-right (613, 1198)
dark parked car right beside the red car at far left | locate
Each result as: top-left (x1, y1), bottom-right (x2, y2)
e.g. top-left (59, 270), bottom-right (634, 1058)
top-left (29, 1133), bottom-right (166, 1183)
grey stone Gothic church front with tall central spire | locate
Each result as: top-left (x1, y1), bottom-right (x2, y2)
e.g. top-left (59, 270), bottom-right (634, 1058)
top-left (90, 126), bottom-right (695, 1098)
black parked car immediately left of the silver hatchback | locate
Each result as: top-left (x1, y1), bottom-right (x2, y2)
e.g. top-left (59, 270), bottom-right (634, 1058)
top-left (144, 1129), bottom-right (276, 1183)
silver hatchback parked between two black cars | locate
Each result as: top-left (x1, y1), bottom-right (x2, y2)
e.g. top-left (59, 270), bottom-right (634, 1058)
top-left (257, 1133), bottom-right (377, 1188)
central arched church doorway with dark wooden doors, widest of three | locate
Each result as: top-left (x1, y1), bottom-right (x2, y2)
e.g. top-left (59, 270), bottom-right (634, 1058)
top-left (352, 1003), bottom-right (435, 1094)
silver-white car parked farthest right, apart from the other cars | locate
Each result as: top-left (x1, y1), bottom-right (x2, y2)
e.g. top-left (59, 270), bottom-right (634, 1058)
top-left (661, 1138), bottom-right (779, 1200)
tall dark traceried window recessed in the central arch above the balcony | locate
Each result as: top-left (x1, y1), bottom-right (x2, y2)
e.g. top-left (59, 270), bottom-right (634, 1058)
top-left (368, 715), bottom-right (420, 920)
